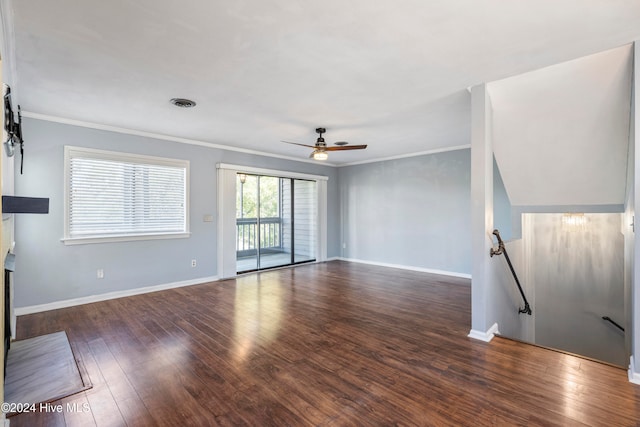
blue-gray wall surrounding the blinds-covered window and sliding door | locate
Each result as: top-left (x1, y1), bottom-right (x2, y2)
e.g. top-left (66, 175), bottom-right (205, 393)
top-left (15, 118), bottom-right (340, 307)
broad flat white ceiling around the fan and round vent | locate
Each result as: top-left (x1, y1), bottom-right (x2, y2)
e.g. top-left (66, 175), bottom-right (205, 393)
top-left (3, 0), bottom-right (640, 164)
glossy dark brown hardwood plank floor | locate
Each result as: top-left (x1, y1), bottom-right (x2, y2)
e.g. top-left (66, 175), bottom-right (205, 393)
top-left (10, 261), bottom-right (640, 427)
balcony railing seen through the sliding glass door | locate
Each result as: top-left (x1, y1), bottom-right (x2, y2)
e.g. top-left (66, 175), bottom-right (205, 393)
top-left (236, 217), bottom-right (282, 257)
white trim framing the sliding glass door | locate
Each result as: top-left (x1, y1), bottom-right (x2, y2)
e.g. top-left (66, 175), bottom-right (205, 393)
top-left (216, 163), bottom-right (329, 278)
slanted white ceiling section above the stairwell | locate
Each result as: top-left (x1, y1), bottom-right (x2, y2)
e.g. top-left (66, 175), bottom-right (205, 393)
top-left (488, 45), bottom-right (633, 206)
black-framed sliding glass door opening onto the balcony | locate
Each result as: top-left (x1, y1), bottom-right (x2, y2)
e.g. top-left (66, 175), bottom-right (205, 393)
top-left (236, 173), bottom-right (317, 273)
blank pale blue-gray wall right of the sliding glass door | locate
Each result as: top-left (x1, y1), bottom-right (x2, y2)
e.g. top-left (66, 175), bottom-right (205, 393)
top-left (339, 149), bottom-right (471, 274)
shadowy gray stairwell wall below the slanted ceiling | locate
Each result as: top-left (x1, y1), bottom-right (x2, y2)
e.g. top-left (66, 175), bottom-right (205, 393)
top-left (523, 213), bottom-right (629, 366)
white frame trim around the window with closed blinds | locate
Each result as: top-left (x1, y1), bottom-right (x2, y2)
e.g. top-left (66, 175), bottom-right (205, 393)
top-left (60, 145), bottom-right (191, 245)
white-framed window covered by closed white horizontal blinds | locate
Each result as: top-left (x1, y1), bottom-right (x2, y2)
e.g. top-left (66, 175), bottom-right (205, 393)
top-left (63, 146), bottom-right (189, 244)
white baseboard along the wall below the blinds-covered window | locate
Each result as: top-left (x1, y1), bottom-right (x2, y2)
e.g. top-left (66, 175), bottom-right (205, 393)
top-left (15, 276), bottom-right (220, 316)
